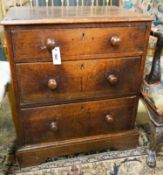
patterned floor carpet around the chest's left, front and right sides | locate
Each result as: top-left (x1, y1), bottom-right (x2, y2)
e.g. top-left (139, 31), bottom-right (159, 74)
top-left (0, 98), bottom-right (163, 175)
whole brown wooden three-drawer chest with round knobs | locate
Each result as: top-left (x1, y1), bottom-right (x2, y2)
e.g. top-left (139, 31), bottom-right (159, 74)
top-left (1, 7), bottom-right (151, 167)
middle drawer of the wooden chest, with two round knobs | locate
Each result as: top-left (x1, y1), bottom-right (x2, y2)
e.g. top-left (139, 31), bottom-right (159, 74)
top-left (16, 58), bottom-right (141, 105)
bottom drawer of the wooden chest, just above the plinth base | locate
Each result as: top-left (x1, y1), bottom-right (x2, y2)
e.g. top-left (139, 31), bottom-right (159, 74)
top-left (21, 97), bottom-right (137, 144)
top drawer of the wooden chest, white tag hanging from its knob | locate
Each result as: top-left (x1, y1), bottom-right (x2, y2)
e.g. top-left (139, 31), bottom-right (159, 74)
top-left (12, 26), bottom-right (146, 62)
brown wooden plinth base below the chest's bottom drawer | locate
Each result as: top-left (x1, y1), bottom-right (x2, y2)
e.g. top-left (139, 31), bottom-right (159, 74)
top-left (17, 130), bottom-right (138, 167)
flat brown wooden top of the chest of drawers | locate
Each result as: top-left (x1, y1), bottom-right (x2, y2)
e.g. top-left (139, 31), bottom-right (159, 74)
top-left (1, 6), bottom-right (153, 25)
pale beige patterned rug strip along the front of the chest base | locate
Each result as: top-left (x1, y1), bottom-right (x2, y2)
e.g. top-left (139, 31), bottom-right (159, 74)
top-left (16, 147), bottom-right (163, 175)
